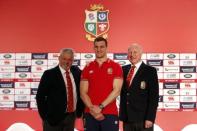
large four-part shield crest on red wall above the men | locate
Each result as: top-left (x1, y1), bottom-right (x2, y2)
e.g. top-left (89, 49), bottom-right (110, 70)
top-left (84, 4), bottom-right (109, 41)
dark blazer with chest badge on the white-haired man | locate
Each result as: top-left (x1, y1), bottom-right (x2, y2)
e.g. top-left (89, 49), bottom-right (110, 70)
top-left (120, 62), bottom-right (159, 122)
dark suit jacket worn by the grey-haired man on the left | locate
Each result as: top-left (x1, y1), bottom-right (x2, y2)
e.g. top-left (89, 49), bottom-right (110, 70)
top-left (36, 66), bottom-right (84, 125)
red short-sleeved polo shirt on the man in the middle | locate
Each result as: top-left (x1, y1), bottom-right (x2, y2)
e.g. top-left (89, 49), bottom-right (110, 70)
top-left (81, 59), bottom-right (122, 115)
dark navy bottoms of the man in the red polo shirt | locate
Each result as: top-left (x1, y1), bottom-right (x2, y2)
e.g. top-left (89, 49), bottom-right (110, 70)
top-left (84, 113), bottom-right (119, 131)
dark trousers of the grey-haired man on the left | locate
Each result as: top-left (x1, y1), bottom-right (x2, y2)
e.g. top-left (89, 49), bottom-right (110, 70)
top-left (43, 113), bottom-right (76, 131)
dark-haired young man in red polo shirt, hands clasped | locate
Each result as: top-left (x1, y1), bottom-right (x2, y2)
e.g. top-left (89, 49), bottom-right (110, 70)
top-left (80, 37), bottom-right (123, 131)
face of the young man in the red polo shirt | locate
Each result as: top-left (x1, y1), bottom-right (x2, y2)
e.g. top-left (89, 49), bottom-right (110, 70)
top-left (94, 41), bottom-right (107, 58)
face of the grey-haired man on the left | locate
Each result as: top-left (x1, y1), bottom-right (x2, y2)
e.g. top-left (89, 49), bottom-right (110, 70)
top-left (59, 53), bottom-right (74, 70)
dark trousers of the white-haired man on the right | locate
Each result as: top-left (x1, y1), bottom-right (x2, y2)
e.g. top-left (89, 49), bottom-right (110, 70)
top-left (123, 122), bottom-right (153, 131)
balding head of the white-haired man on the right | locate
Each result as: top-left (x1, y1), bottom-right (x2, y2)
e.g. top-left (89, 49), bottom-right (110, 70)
top-left (128, 43), bottom-right (143, 65)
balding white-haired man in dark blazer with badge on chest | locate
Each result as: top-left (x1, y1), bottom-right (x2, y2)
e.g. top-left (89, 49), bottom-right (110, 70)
top-left (119, 44), bottom-right (159, 131)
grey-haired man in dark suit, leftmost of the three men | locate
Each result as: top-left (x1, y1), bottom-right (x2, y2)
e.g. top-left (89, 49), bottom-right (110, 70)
top-left (36, 48), bottom-right (84, 131)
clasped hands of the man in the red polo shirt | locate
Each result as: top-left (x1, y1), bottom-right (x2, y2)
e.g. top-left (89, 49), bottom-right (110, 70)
top-left (89, 105), bottom-right (105, 121)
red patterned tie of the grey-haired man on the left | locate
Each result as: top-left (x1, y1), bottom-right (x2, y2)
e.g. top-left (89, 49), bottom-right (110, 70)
top-left (66, 71), bottom-right (74, 112)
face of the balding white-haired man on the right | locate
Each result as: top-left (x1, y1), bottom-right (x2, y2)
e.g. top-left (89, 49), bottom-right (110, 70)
top-left (128, 46), bottom-right (142, 65)
